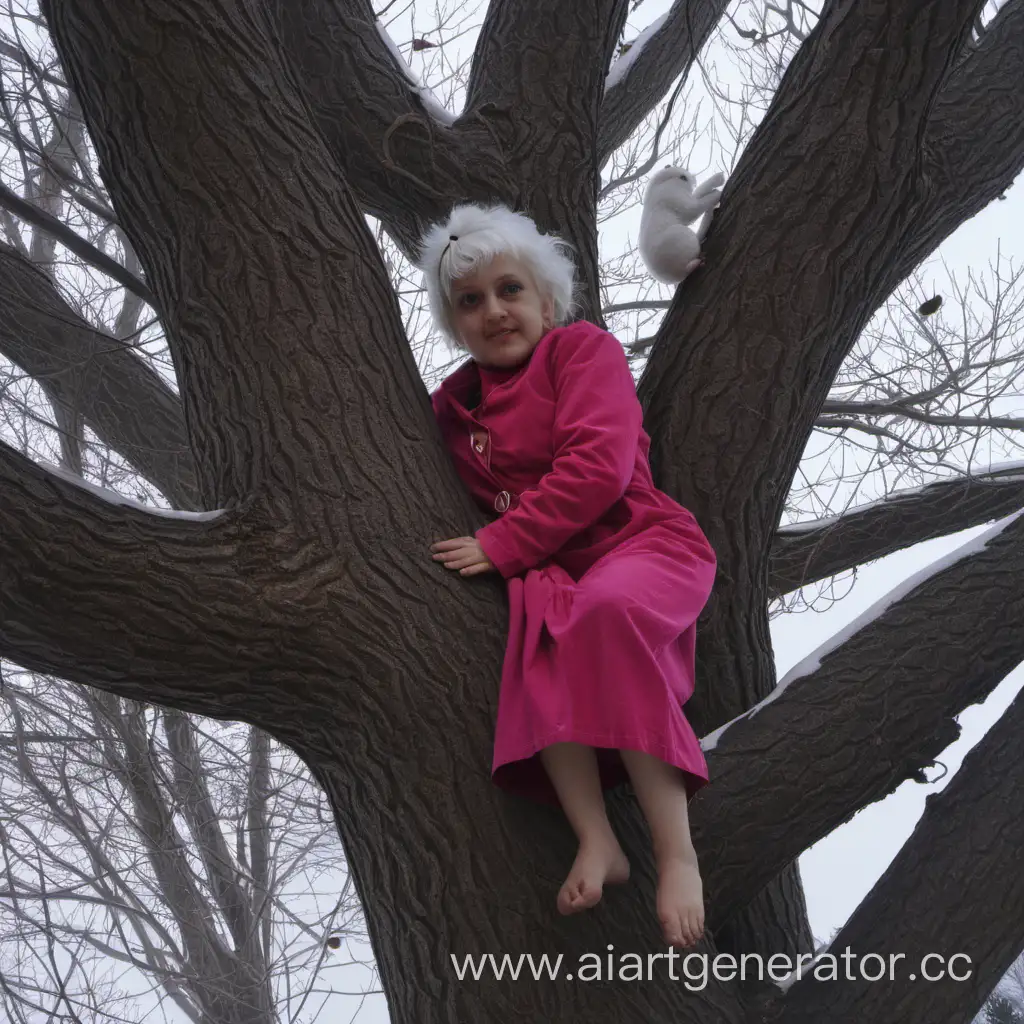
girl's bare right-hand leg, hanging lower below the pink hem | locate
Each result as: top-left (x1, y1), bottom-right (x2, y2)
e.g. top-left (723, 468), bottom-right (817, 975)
top-left (618, 751), bottom-right (705, 946)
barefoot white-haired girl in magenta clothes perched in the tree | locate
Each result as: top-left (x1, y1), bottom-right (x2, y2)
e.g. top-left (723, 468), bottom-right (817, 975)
top-left (421, 205), bottom-right (715, 946)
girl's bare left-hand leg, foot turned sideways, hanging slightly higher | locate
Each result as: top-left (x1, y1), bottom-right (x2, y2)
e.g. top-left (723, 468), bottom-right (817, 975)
top-left (541, 743), bottom-right (630, 913)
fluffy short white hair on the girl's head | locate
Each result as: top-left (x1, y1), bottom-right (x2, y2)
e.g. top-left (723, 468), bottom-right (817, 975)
top-left (419, 203), bottom-right (575, 348)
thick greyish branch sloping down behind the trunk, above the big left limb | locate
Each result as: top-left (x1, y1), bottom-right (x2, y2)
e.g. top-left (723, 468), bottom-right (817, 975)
top-left (0, 244), bottom-right (199, 509)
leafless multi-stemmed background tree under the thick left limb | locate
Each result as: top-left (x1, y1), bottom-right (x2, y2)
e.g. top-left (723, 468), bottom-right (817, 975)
top-left (0, 673), bottom-right (361, 1024)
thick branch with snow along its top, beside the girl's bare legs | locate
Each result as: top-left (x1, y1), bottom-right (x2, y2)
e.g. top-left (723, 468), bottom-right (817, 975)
top-left (693, 512), bottom-right (1024, 926)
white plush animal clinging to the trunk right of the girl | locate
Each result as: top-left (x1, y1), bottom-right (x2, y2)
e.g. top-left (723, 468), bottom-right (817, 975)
top-left (640, 167), bottom-right (725, 285)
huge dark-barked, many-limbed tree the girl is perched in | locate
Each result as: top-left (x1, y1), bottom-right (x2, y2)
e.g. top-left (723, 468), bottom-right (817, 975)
top-left (0, 0), bottom-right (1024, 1024)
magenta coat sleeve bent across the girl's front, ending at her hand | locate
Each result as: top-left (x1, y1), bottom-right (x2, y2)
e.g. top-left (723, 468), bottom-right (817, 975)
top-left (476, 323), bottom-right (643, 579)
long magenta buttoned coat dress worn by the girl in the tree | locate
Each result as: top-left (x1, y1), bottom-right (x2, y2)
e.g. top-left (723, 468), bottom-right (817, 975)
top-left (431, 321), bottom-right (716, 804)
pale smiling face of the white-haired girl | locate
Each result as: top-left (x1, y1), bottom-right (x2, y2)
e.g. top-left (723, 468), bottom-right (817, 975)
top-left (452, 254), bottom-right (554, 370)
